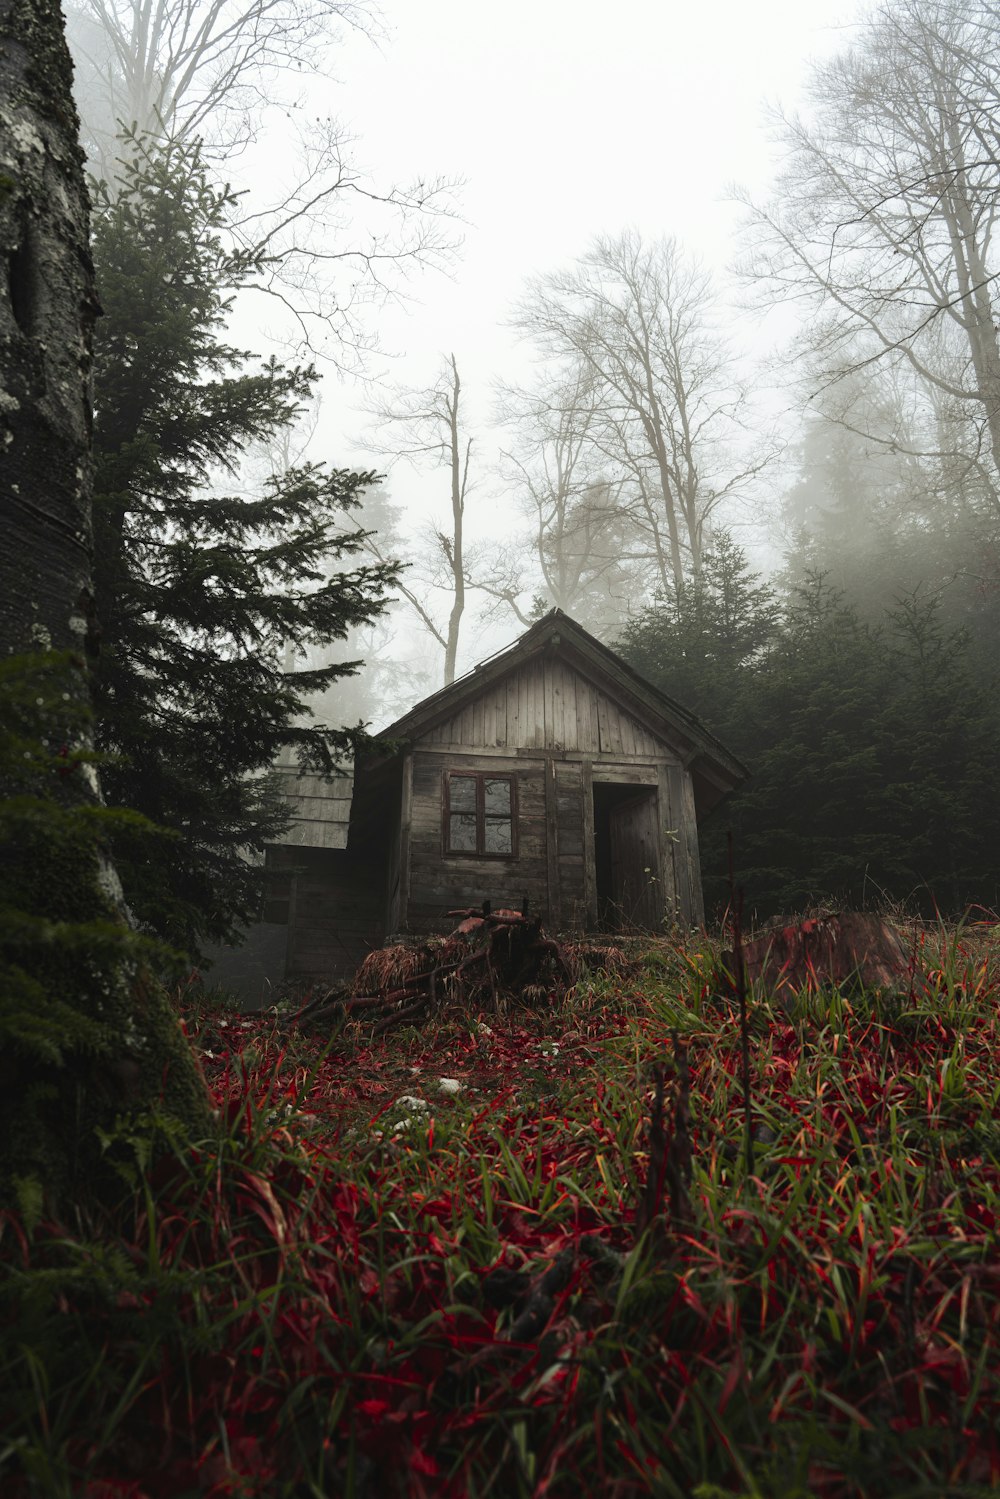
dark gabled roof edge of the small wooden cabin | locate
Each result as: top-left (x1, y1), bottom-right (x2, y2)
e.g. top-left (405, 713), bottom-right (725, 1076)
top-left (378, 609), bottom-right (750, 811)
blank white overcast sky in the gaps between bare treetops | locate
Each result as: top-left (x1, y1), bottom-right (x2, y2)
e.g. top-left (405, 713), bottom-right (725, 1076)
top-left (238, 0), bottom-right (858, 689)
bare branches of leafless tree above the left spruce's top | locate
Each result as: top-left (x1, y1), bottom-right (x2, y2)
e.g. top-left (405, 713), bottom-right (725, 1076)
top-left (70, 0), bottom-right (457, 372)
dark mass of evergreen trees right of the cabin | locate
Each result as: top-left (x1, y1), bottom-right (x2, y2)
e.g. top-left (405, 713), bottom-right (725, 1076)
top-left (619, 544), bottom-right (1000, 919)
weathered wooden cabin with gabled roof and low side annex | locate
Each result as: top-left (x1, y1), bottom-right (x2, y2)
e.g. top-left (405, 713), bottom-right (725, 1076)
top-left (206, 610), bottom-right (747, 1007)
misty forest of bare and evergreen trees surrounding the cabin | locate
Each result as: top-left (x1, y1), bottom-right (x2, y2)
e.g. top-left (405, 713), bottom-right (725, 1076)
top-left (58, 0), bottom-right (1000, 950)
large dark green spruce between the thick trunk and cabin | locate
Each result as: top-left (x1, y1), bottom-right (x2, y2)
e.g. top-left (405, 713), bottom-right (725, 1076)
top-left (94, 142), bottom-right (394, 952)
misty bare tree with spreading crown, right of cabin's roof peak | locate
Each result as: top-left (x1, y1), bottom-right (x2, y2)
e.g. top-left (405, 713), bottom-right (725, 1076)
top-left (514, 231), bottom-right (771, 591)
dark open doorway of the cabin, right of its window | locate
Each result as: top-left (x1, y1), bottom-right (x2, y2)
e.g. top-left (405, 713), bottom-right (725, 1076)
top-left (594, 781), bottom-right (663, 931)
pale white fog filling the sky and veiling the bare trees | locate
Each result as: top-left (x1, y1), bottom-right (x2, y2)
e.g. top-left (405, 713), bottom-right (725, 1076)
top-left (70, 0), bottom-right (1000, 724)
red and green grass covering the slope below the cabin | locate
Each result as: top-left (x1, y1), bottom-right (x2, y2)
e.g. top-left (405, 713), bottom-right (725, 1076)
top-left (4, 929), bottom-right (1000, 1499)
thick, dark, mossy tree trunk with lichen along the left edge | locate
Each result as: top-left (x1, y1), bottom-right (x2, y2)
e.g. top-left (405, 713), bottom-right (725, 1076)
top-left (0, 0), bottom-right (210, 1205)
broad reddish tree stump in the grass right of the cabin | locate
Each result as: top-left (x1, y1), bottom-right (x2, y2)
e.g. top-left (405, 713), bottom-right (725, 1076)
top-left (723, 911), bottom-right (915, 994)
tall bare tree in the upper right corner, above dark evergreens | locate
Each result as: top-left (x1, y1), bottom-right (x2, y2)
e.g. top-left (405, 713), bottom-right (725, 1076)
top-left (741, 0), bottom-right (1000, 502)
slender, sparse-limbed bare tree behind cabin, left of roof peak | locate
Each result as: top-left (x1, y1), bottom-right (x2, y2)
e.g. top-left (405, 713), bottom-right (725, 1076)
top-left (369, 354), bottom-right (472, 687)
